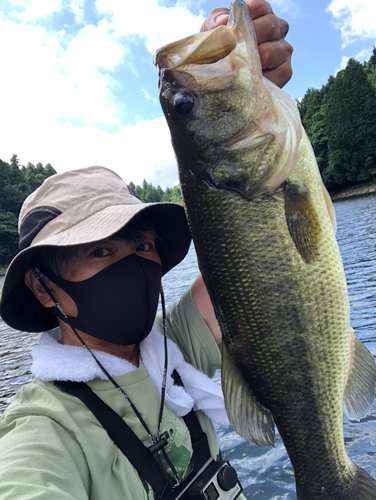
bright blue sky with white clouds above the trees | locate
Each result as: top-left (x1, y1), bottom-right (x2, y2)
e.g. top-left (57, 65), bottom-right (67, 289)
top-left (0, 0), bottom-right (376, 188)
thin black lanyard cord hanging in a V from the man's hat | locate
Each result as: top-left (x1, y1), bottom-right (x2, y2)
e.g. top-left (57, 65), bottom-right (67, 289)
top-left (31, 267), bottom-right (170, 448)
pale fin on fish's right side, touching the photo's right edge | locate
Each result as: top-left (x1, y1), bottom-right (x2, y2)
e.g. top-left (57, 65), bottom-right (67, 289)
top-left (343, 328), bottom-right (376, 420)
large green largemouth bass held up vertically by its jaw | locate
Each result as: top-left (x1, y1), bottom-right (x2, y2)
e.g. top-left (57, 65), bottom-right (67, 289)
top-left (154, 0), bottom-right (376, 500)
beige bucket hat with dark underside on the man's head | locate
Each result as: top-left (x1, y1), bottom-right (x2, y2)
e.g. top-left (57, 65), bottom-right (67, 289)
top-left (0, 167), bottom-right (191, 332)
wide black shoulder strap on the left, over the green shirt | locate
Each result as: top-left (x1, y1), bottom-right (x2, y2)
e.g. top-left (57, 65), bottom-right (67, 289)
top-left (55, 381), bottom-right (167, 495)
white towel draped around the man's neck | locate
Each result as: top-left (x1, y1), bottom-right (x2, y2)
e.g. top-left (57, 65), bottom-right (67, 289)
top-left (31, 328), bottom-right (229, 426)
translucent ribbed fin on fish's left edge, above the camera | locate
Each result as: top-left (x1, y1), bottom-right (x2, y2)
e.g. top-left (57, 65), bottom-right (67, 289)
top-left (222, 344), bottom-right (275, 446)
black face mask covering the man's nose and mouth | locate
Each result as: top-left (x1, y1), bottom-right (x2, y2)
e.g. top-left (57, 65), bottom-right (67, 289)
top-left (41, 254), bottom-right (162, 345)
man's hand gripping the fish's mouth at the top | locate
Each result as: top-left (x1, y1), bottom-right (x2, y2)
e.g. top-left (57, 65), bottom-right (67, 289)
top-left (201, 0), bottom-right (293, 88)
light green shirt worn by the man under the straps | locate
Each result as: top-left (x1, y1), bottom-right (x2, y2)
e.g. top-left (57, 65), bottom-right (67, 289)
top-left (0, 291), bottom-right (244, 500)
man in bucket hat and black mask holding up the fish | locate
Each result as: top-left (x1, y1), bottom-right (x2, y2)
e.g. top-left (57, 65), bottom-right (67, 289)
top-left (0, 0), bottom-right (291, 500)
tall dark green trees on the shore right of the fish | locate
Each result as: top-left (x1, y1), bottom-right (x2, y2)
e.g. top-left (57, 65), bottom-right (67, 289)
top-left (297, 47), bottom-right (376, 191)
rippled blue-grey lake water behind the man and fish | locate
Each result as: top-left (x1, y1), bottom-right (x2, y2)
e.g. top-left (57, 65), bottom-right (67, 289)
top-left (0, 195), bottom-right (376, 500)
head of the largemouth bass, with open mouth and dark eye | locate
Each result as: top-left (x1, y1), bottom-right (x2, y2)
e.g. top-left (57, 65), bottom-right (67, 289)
top-left (155, 0), bottom-right (300, 198)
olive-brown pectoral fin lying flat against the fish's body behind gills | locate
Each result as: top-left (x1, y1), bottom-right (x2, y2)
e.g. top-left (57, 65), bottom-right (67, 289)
top-left (285, 179), bottom-right (322, 264)
